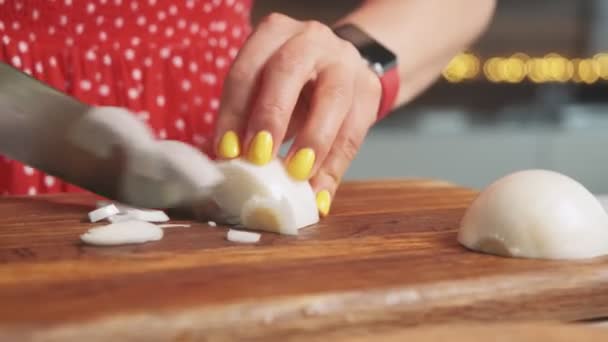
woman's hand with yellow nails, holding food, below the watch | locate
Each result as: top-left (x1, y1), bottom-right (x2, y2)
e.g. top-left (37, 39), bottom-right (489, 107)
top-left (214, 14), bottom-right (381, 216)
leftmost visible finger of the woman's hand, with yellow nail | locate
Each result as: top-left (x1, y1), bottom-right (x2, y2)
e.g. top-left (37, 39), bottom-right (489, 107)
top-left (214, 14), bottom-right (300, 158)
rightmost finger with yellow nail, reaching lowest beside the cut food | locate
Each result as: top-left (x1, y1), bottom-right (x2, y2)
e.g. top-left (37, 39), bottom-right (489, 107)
top-left (311, 69), bottom-right (381, 216)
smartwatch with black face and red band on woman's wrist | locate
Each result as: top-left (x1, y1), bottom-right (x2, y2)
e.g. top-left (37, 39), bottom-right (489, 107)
top-left (333, 24), bottom-right (400, 120)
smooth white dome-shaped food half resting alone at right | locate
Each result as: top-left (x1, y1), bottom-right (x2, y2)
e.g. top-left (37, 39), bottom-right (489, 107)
top-left (458, 170), bottom-right (608, 259)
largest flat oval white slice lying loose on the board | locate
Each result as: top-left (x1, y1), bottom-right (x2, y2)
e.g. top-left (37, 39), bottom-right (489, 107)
top-left (80, 221), bottom-right (163, 246)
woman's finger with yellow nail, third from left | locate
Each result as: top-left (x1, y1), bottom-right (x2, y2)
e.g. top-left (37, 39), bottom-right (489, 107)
top-left (287, 57), bottom-right (356, 180)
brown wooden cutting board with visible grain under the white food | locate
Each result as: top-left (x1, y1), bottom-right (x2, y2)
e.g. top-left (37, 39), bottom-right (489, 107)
top-left (0, 180), bottom-right (608, 341)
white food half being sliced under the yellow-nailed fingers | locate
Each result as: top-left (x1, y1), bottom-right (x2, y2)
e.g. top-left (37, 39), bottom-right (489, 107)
top-left (213, 159), bottom-right (319, 235)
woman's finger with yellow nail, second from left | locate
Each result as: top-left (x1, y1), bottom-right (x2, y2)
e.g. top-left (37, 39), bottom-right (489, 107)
top-left (245, 23), bottom-right (337, 165)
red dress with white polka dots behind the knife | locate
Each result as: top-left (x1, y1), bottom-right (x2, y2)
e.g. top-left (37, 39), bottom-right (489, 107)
top-left (0, 0), bottom-right (252, 195)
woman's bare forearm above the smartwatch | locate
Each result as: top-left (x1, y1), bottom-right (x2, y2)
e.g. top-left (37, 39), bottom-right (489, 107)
top-left (340, 0), bottom-right (495, 106)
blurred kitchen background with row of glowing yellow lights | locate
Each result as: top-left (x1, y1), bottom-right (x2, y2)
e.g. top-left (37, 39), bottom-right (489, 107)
top-left (254, 0), bottom-right (608, 193)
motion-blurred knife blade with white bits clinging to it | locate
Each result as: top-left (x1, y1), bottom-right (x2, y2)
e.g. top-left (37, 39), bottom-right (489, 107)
top-left (0, 62), bottom-right (223, 208)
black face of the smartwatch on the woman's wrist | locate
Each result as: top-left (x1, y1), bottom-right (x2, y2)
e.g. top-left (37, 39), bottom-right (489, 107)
top-left (334, 24), bottom-right (397, 71)
